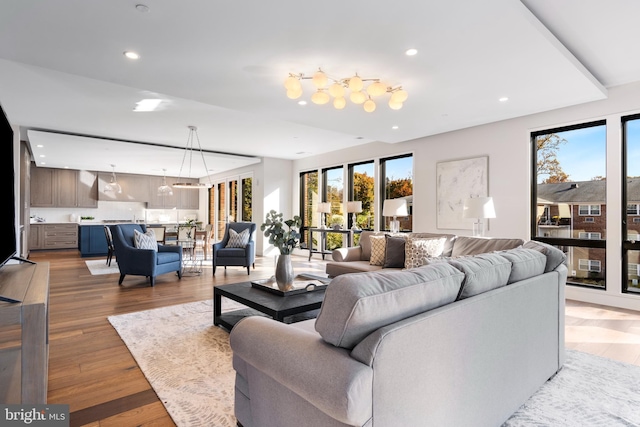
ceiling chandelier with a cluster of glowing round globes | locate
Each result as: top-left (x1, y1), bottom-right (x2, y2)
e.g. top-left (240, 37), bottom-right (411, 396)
top-left (284, 69), bottom-right (409, 113)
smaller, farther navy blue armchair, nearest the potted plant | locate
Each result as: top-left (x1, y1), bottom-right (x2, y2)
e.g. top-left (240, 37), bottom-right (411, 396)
top-left (212, 222), bottom-right (256, 276)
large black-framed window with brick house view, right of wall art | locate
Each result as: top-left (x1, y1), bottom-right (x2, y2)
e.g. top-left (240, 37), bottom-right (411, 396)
top-left (531, 120), bottom-right (607, 289)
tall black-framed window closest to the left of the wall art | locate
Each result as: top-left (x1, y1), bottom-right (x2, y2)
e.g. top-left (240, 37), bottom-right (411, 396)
top-left (380, 154), bottom-right (413, 231)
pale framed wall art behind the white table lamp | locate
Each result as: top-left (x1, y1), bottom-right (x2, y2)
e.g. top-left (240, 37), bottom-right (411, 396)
top-left (436, 156), bottom-right (489, 230)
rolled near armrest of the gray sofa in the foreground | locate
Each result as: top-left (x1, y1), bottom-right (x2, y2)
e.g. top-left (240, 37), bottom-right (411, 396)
top-left (229, 316), bottom-right (373, 425)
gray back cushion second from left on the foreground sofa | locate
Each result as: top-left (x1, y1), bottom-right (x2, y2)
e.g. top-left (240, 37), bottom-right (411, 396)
top-left (448, 254), bottom-right (511, 299)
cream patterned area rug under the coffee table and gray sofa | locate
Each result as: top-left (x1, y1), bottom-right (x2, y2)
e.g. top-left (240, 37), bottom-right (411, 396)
top-left (109, 299), bottom-right (640, 427)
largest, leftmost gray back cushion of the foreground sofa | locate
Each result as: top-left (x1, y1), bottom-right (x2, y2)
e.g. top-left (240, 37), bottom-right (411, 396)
top-left (315, 264), bottom-right (464, 349)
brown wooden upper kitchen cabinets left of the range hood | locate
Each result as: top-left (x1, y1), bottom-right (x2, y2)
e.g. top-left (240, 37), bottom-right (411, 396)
top-left (30, 164), bottom-right (98, 208)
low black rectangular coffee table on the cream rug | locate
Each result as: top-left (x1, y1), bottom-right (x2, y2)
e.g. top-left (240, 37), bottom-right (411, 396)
top-left (213, 282), bottom-right (325, 331)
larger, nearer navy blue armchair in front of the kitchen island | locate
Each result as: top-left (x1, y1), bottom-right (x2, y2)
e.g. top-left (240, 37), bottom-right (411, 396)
top-left (111, 224), bottom-right (182, 286)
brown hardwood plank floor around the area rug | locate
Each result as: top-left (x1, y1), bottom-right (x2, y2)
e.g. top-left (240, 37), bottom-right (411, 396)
top-left (30, 251), bottom-right (640, 427)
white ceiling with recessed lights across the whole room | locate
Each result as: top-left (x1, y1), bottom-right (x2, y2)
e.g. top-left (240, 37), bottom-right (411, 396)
top-left (0, 0), bottom-right (640, 177)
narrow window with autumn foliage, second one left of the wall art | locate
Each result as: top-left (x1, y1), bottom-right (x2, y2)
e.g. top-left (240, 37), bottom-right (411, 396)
top-left (347, 160), bottom-right (375, 231)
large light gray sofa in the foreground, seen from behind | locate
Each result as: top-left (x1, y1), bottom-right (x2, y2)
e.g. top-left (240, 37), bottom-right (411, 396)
top-left (230, 237), bottom-right (567, 427)
